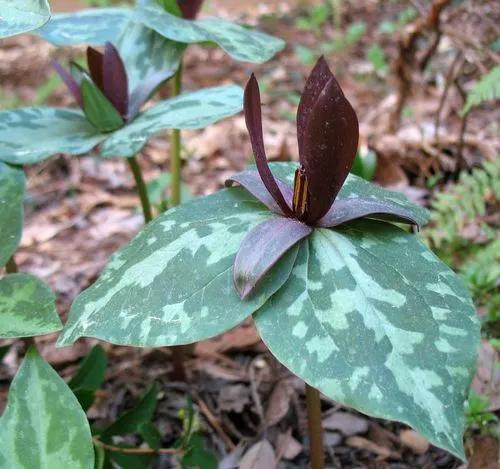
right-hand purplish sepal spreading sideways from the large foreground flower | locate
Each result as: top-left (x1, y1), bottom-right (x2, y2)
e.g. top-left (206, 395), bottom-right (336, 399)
top-left (317, 197), bottom-right (418, 228)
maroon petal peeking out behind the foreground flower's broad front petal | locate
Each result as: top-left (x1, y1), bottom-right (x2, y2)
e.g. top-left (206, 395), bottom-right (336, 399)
top-left (297, 56), bottom-right (333, 154)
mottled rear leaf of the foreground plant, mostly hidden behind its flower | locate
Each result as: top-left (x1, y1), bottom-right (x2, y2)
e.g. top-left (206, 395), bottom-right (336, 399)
top-left (269, 163), bottom-right (429, 225)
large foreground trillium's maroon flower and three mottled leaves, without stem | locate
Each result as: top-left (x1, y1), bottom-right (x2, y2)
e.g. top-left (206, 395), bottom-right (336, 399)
top-left (59, 60), bottom-right (479, 458)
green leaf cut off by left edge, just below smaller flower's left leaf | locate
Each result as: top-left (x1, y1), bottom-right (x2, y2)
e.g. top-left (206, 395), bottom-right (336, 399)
top-left (0, 161), bottom-right (26, 267)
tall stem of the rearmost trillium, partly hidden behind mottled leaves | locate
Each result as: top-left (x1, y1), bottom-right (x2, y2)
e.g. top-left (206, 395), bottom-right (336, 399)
top-left (170, 61), bottom-right (191, 381)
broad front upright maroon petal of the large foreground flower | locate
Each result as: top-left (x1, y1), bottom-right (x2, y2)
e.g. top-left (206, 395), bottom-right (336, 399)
top-left (300, 72), bottom-right (359, 223)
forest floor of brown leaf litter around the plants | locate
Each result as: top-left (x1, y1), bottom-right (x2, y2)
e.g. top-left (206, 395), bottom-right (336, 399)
top-left (0, 0), bottom-right (500, 469)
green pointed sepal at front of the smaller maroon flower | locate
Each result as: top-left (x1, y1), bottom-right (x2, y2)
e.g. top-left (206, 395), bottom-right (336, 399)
top-left (80, 78), bottom-right (124, 133)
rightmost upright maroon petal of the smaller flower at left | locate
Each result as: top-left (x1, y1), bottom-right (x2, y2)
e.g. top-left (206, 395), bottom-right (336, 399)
top-left (103, 42), bottom-right (128, 117)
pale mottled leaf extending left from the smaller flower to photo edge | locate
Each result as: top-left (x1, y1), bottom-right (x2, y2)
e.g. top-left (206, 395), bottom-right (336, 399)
top-left (0, 107), bottom-right (106, 164)
